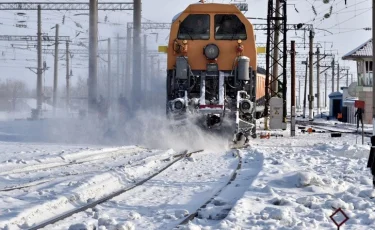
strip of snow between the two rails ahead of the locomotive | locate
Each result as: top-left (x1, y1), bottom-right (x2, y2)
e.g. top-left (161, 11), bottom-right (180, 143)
top-left (45, 151), bottom-right (238, 229)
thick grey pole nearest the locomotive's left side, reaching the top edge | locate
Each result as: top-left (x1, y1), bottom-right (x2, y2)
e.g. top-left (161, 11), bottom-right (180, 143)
top-left (132, 0), bottom-right (144, 110)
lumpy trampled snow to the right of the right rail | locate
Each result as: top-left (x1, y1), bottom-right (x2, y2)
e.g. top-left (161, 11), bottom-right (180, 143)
top-left (188, 127), bottom-right (375, 229)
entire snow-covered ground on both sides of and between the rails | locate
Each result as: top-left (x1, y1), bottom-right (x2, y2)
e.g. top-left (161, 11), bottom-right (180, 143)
top-left (0, 117), bottom-right (375, 230)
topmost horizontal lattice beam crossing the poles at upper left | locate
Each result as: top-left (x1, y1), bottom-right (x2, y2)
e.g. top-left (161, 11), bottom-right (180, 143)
top-left (0, 2), bottom-right (134, 10)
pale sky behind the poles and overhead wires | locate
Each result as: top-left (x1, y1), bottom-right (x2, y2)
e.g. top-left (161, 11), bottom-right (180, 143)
top-left (0, 0), bottom-right (372, 95)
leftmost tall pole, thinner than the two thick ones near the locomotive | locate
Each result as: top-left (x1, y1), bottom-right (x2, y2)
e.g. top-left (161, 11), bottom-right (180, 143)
top-left (36, 5), bottom-right (43, 119)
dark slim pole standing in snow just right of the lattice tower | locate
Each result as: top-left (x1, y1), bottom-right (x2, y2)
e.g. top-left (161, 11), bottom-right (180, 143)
top-left (290, 41), bottom-right (296, 137)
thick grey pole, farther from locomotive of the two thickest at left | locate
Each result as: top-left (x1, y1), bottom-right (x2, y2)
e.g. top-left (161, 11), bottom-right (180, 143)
top-left (88, 0), bottom-right (98, 112)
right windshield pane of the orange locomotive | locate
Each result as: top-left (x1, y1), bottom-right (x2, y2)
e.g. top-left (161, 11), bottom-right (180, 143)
top-left (215, 14), bottom-right (247, 40)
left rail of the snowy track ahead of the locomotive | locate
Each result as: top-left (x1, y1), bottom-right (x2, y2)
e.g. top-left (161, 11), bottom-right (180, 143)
top-left (29, 150), bottom-right (204, 230)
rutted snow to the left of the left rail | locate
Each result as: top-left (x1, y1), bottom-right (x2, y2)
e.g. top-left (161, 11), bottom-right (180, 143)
top-left (0, 143), bottom-right (179, 229)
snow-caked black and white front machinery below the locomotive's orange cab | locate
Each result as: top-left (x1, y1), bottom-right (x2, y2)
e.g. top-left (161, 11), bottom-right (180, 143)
top-left (166, 56), bottom-right (257, 144)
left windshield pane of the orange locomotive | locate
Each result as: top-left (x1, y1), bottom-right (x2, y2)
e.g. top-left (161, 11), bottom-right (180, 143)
top-left (178, 14), bottom-right (210, 40)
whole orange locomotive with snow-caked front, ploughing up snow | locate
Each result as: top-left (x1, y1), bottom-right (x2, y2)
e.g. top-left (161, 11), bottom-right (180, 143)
top-left (166, 0), bottom-right (265, 142)
